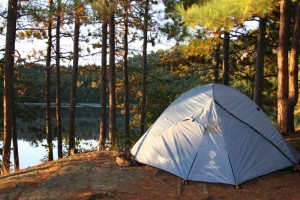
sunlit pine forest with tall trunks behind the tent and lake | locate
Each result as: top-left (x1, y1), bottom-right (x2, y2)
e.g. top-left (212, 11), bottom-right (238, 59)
top-left (0, 0), bottom-right (300, 175)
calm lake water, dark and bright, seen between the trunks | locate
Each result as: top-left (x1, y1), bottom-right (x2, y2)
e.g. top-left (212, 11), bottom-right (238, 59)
top-left (0, 104), bottom-right (117, 169)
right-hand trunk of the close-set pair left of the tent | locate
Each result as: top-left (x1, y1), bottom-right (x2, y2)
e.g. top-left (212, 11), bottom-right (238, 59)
top-left (109, 5), bottom-right (116, 148)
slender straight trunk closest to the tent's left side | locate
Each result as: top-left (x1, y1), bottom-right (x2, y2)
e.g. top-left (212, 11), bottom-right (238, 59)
top-left (140, 0), bottom-right (149, 134)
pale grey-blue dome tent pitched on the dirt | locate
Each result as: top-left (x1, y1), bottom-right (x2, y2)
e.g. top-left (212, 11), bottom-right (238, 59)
top-left (131, 84), bottom-right (300, 185)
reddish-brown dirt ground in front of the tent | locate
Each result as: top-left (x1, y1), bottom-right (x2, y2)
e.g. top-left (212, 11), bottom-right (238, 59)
top-left (0, 137), bottom-right (300, 200)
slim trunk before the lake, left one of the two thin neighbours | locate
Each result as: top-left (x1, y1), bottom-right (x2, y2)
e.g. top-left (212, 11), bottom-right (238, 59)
top-left (46, 0), bottom-right (53, 161)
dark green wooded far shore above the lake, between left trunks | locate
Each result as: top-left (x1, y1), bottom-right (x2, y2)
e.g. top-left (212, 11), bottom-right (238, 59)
top-left (15, 65), bottom-right (100, 103)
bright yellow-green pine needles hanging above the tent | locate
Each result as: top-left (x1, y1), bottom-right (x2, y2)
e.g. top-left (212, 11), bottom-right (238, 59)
top-left (176, 0), bottom-right (274, 31)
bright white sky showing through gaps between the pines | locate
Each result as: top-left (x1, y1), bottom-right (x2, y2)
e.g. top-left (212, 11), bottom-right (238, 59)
top-left (0, 0), bottom-right (175, 66)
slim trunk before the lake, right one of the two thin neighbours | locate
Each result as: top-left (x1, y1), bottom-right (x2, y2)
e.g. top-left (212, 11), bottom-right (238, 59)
top-left (56, 0), bottom-right (63, 158)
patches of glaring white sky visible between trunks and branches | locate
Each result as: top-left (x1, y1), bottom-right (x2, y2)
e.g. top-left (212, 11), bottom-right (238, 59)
top-left (0, 0), bottom-right (175, 65)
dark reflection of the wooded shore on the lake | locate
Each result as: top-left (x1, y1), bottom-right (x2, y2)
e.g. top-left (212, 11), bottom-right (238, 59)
top-left (17, 103), bottom-right (101, 141)
